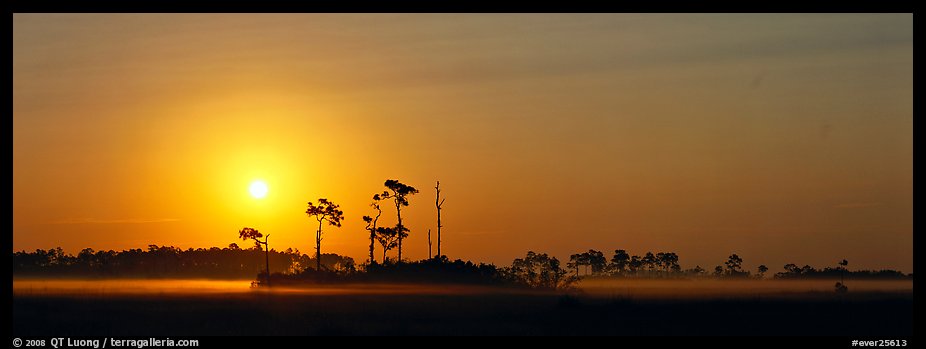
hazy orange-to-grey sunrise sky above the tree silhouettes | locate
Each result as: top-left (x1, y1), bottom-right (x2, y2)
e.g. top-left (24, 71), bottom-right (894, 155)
top-left (13, 14), bottom-right (913, 272)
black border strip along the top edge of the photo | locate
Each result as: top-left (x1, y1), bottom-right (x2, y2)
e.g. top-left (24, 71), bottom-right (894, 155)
top-left (11, 0), bottom-right (913, 13)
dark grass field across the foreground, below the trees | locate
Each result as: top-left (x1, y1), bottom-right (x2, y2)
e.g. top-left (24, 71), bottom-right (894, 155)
top-left (13, 282), bottom-right (913, 336)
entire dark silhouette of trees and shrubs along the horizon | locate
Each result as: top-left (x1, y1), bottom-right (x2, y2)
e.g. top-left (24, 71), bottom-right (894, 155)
top-left (13, 179), bottom-right (913, 292)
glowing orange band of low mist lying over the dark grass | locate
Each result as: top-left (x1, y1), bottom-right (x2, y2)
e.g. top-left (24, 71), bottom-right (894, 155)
top-left (13, 278), bottom-right (913, 299)
